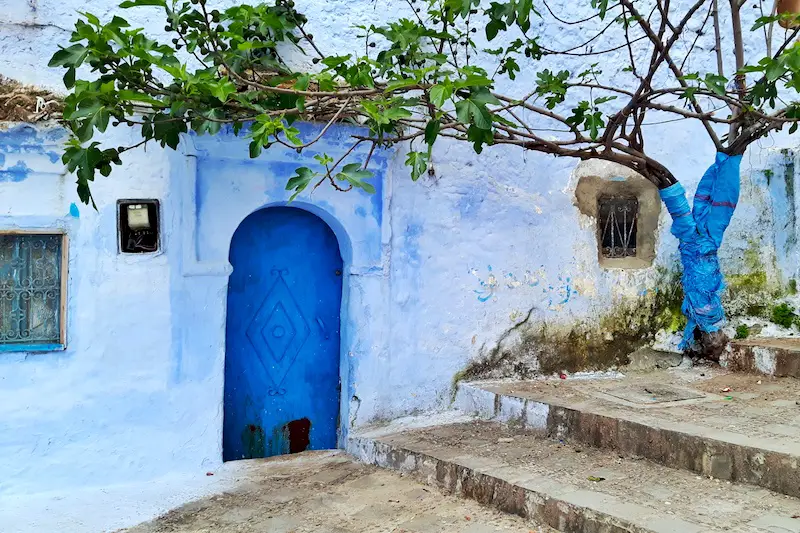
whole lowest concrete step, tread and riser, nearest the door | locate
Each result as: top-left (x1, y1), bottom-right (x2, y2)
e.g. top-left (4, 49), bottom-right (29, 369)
top-left (349, 421), bottom-right (800, 533)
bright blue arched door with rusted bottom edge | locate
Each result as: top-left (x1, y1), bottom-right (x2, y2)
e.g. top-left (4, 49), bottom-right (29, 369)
top-left (223, 207), bottom-right (342, 461)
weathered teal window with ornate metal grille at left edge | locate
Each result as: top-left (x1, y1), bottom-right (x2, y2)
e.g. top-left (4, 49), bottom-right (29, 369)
top-left (0, 234), bottom-right (63, 345)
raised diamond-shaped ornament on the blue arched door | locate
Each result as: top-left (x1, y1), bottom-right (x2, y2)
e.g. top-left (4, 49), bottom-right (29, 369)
top-left (245, 270), bottom-right (311, 395)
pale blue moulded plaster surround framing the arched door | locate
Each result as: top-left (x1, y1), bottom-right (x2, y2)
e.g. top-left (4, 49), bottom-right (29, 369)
top-left (167, 124), bottom-right (390, 460)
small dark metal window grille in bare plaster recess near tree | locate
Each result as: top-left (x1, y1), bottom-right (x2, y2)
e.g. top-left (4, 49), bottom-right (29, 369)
top-left (597, 196), bottom-right (639, 259)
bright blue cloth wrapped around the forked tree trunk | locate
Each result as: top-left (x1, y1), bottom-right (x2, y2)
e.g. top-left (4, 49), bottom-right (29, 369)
top-left (659, 153), bottom-right (742, 349)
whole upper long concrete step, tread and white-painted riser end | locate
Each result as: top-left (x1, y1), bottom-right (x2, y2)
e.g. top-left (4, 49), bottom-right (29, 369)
top-left (455, 369), bottom-right (800, 498)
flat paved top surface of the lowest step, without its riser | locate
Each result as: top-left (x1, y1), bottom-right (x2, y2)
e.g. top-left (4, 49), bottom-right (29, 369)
top-left (364, 422), bottom-right (800, 533)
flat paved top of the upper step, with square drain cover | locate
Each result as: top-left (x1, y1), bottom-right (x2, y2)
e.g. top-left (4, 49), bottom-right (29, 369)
top-left (481, 367), bottom-right (800, 444)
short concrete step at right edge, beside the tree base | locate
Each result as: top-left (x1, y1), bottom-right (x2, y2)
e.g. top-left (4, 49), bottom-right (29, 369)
top-left (721, 338), bottom-right (800, 378)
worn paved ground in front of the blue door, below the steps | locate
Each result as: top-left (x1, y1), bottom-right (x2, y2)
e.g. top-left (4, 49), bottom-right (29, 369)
top-left (120, 452), bottom-right (553, 533)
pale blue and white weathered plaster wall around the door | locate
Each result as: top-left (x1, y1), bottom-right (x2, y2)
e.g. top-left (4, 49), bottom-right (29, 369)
top-left (0, 0), bottom-right (797, 502)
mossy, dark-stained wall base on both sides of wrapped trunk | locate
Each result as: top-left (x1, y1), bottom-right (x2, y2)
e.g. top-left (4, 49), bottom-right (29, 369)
top-left (460, 240), bottom-right (789, 385)
